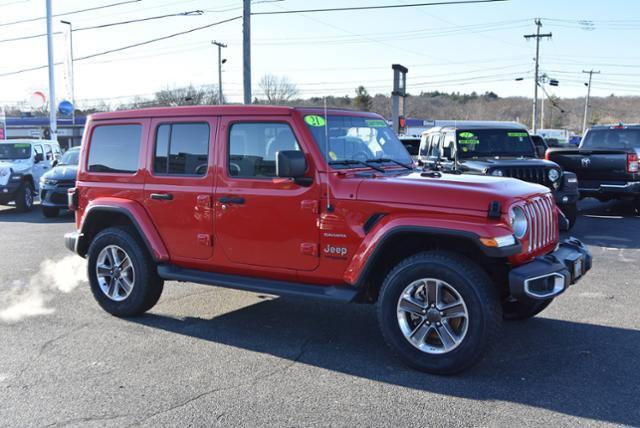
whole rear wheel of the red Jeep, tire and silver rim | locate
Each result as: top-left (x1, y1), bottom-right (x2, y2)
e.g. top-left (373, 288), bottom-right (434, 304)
top-left (87, 227), bottom-right (164, 317)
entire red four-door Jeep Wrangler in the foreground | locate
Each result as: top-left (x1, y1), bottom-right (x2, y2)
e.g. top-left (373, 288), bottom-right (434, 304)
top-left (65, 106), bottom-right (591, 373)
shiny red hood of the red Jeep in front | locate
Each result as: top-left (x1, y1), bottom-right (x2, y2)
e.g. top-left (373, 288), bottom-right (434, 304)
top-left (357, 172), bottom-right (549, 212)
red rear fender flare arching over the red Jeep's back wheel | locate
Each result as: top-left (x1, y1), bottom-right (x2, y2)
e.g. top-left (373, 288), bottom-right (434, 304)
top-left (78, 198), bottom-right (169, 262)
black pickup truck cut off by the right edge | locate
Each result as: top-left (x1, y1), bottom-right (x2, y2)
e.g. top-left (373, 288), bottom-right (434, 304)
top-left (546, 124), bottom-right (640, 210)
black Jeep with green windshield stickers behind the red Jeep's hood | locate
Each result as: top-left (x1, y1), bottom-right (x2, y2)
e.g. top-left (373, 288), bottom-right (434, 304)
top-left (418, 122), bottom-right (579, 227)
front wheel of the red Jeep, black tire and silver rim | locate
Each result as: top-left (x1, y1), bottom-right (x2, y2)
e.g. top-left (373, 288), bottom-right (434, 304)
top-left (378, 251), bottom-right (502, 374)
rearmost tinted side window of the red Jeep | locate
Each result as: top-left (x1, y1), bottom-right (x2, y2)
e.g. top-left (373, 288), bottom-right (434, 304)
top-left (87, 124), bottom-right (142, 174)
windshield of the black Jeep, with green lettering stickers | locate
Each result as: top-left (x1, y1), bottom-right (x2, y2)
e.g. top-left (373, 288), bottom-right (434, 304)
top-left (457, 129), bottom-right (536, 158)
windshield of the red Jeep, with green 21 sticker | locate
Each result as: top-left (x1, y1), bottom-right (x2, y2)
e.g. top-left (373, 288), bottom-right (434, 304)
top-left (304, 115), bottom-right (412, 168)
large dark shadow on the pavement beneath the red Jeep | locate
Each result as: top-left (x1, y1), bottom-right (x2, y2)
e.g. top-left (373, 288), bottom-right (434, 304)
top-left (131, 298), bottom-right (640, 425)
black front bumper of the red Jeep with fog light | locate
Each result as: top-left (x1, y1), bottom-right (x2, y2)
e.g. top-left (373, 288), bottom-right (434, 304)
top-left (509, 238), bottom-right (592, 299)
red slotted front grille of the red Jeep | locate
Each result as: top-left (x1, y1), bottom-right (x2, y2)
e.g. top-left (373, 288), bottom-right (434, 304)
top-left (522, 194), bottom-right (558, 253)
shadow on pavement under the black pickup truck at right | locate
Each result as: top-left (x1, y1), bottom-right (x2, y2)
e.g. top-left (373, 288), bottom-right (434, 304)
top-left (568, 199), bottom-right (640, 249)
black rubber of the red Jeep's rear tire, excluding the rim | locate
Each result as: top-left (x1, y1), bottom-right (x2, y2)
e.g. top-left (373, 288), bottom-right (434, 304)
top-left (87, 227), bottom-right (164, 317)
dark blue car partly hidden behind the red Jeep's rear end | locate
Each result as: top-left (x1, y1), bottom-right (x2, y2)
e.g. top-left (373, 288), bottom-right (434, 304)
top-left (40, 147), bottom-right (80, 217)
